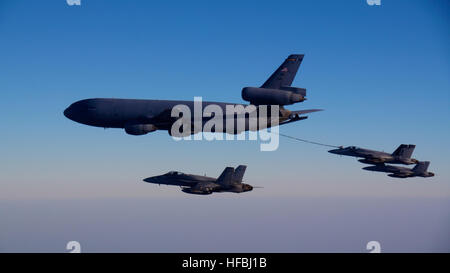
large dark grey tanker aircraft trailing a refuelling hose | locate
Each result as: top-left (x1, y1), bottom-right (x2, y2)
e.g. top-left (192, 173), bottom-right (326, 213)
top-left (64, 54), bottom-right (321, 136)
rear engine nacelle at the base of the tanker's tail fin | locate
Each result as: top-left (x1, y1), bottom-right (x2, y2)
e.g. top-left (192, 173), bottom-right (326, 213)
top-left (242, 87), bottom-right (305, 105)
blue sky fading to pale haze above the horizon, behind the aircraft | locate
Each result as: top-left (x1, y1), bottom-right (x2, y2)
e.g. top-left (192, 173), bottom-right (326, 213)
top-left (0, 0), bottom-right (450, 251)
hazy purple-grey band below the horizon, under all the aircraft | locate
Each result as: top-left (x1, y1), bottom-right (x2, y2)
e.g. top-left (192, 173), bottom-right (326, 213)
top-left (0, 196), bottom-right (450, 252)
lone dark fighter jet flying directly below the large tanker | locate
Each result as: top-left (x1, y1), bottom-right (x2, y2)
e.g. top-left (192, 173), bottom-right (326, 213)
top-left (144, 165), bottom-right (253, 195)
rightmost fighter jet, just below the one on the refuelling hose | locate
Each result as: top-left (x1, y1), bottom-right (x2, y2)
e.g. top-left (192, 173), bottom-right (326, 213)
top-left (363, 161), bottom-right (434, 178)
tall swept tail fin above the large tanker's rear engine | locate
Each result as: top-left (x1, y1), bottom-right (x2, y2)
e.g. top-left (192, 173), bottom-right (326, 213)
top-left (261, 54), bottom-right (304, 89)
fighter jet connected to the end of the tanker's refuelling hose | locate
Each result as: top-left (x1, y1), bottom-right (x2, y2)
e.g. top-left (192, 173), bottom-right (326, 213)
top-left (328, 144), bottom-right (419, 165)
